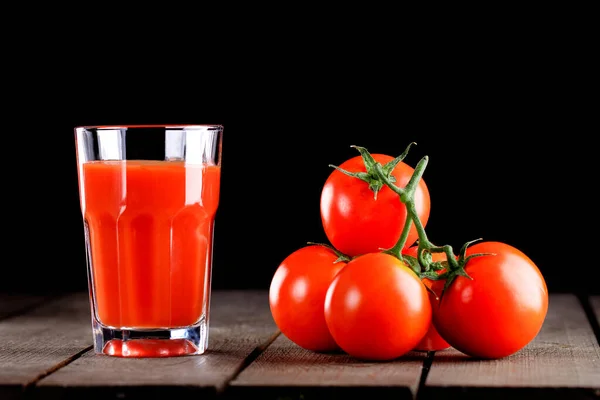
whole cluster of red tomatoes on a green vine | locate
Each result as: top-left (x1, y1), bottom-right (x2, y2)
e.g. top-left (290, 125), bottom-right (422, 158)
top-left (269, 146), bottom-right (548, 361)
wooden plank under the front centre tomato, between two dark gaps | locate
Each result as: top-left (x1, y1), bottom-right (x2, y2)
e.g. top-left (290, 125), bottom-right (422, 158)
top-left (227, 335), bottom-right (426, 399)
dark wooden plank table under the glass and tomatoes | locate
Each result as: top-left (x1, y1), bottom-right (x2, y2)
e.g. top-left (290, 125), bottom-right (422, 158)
top-left (0, 291), bottom-right (600, 400)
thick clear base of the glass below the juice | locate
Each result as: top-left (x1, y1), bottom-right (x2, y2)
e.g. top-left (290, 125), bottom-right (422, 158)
top-left (92, 318), bottom-right (208, 358)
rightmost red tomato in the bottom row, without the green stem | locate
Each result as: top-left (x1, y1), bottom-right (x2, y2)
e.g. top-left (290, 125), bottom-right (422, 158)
top-left (433, 242), bottom-right (548, 359)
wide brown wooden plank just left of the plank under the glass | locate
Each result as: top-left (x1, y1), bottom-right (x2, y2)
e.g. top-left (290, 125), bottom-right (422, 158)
top-left (0, 294), bottom-right (92, 399)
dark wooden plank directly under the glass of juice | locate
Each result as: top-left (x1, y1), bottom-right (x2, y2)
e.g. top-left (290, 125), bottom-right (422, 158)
top-left (36, 291), bottom-right (277, 399)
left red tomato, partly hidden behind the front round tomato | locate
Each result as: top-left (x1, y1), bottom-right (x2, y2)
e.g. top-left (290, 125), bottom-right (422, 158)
top-left (269, 245), bottom-right (346, 352)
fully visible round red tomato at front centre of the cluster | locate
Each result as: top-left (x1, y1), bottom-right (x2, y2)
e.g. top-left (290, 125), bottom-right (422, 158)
top-left (325, 253), bottom-right (431, 361)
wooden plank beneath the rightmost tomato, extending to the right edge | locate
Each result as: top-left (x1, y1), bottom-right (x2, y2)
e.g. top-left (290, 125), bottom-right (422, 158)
top-left (419, 294), bottom-right (600, 399)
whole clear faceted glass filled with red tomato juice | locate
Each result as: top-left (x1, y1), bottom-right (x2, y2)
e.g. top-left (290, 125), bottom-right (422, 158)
top-left (75, 125), bottom-right (223, 357)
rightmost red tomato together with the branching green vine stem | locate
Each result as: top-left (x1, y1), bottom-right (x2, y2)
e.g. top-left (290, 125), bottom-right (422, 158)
top-left (374, 147), bottom-right (548, 359)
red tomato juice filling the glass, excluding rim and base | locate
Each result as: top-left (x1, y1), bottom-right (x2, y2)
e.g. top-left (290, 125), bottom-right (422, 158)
top-left (79, 160), bottom-right (220, 329)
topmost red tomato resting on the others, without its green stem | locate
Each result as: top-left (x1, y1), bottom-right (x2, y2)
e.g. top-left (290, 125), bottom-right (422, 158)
top-left (320, 154), bottom-right (430, 257)
